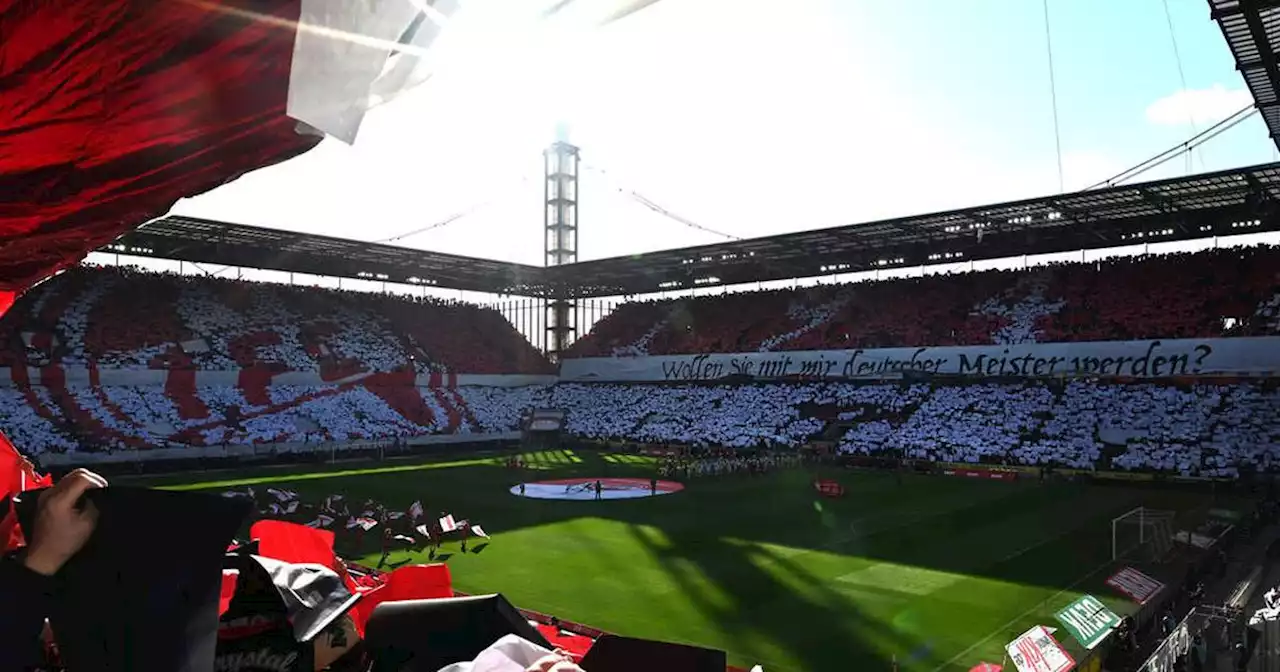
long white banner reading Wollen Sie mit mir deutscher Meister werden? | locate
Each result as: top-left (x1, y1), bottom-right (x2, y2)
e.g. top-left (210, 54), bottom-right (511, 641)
top-left (561, 337), bottom-right (1280, 383)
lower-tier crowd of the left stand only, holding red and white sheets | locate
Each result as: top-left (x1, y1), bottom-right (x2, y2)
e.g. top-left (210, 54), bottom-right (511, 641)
top-left (0, 385), bottom-right (563, 453)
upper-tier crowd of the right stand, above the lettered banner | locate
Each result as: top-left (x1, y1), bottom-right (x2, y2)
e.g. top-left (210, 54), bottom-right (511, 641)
top-left (571, 247), bottom-right (1280, 357)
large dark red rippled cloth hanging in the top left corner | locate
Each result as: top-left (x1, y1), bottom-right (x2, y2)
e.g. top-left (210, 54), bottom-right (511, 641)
top-left (0, 0), bottom-right (320, 291)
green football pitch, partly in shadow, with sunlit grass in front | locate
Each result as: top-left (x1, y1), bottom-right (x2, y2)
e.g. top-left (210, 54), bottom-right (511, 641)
top-left (137, 451), bottom-right (1222, 672)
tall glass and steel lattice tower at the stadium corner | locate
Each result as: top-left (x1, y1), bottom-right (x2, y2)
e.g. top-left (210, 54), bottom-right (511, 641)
top-left (543, 133), bottom-right (579, 361)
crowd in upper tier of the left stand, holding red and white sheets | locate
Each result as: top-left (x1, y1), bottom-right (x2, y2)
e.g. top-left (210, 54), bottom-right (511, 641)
top-left (0, 266), bottom-right (550, 374)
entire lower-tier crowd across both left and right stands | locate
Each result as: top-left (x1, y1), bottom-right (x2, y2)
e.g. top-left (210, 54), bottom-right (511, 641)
top-left (0, 380), bottom-right (1280, 476)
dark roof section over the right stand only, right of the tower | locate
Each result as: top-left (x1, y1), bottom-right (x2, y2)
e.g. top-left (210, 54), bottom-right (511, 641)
top-left (563, 163), bottom-right (1280, 294)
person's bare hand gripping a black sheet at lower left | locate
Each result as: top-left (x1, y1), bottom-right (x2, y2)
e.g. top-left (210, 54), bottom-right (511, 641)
top-left (24, 468), bottom-right (106, 576)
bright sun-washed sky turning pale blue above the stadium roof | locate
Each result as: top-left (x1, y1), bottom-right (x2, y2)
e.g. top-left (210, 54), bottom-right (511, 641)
top-left (167, 0), bottom-right (1275, 264)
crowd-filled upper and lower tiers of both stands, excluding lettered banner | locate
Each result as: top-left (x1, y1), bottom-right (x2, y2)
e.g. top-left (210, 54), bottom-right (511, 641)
top-left (0, 247), bottom-right (1280, 476)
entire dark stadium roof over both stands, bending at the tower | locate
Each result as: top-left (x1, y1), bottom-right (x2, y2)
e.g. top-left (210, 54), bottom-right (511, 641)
top-left (115, 163), bottom-right (1280, 298)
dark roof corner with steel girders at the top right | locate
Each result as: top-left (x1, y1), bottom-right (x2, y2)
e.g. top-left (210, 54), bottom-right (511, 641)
top-left (1208, 0), bottom-right (1280, 147)
